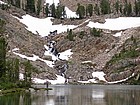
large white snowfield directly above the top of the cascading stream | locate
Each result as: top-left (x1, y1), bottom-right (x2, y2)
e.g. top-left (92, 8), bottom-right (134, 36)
top-left (16, 14), bottom-right (77, 37)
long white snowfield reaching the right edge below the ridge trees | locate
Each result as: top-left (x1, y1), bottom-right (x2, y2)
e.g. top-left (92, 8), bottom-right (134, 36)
top-left (87, 17), bottom-right (140, 30)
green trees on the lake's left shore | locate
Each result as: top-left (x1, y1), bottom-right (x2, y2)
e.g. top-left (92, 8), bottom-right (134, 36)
top-left (0, 19), bottom-right (34, 90)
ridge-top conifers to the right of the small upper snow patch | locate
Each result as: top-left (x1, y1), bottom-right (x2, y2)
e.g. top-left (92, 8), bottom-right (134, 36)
top-left (76, 0), bottom-right (140, 19)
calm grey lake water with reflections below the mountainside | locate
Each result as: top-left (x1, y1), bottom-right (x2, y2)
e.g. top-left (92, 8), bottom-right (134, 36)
top-left (0, 85), bottom-right (140, 105)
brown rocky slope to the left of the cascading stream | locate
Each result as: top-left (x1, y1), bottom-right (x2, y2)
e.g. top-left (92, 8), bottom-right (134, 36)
top-left (0, 8), bottom-right (55, 79)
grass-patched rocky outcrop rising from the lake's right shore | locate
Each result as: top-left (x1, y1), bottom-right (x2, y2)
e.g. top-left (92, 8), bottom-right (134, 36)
top-left (104, 28), bottom-right (140, 81)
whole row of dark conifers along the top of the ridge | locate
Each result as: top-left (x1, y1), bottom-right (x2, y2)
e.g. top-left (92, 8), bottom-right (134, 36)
top-left (1, 0), bottom-right (140, 19)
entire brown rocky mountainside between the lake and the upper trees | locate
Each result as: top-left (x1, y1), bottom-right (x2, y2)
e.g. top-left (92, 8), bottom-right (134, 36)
top-left (0, 0), bottom-right (140, 83)
